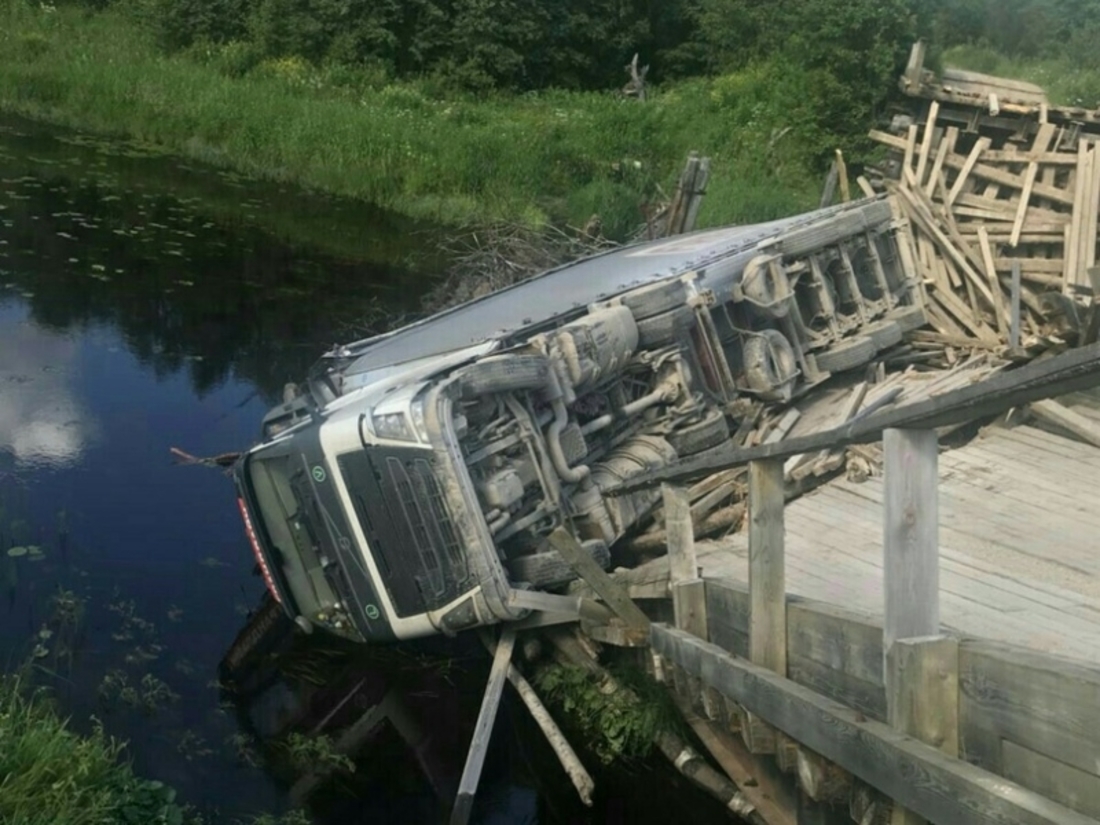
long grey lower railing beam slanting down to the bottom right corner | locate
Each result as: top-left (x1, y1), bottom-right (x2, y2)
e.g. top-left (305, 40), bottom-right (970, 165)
top-left (650, 625), bottom-right (1096, 825)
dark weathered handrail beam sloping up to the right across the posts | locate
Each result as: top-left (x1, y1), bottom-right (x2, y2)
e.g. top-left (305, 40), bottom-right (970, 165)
top-left (605, 343), bottom-right (1100, 493)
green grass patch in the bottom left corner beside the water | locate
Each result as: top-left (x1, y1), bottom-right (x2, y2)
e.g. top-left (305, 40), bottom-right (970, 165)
top-left (0, 675), bottom-right (184, 825)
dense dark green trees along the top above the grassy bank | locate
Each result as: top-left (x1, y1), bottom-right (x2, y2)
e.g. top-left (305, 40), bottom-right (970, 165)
top-left (109, 0), bottom-right (932, 137)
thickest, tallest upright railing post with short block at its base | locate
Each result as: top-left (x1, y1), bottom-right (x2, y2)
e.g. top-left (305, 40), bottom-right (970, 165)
top-left (882, 429), bottom-right (958, 825)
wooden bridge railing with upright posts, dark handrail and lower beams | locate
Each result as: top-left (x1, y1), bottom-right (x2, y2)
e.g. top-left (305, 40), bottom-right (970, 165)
top-left (649, 338), bottom-right (1100, 825)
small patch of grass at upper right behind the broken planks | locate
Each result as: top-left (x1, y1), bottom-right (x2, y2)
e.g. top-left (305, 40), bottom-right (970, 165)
top-left (942, 45), bottom-right (1100, 109)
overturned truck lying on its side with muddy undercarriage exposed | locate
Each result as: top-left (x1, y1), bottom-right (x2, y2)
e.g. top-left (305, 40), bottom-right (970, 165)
top-left (234, 198), bottom-right (925, 642)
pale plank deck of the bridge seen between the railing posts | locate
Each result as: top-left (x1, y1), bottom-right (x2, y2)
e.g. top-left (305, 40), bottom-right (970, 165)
top-left (626, 426), bottom-right (1100, 662)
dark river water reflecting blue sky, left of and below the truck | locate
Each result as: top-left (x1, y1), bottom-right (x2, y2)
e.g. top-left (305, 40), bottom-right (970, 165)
top-left (0, 111), bottom-right (739, 823)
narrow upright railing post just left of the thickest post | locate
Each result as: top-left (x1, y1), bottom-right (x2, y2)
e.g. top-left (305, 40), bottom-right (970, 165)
top-left (749, 461), bottom-right (787, 675)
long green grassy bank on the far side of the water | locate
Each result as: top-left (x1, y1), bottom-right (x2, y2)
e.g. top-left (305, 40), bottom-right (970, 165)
top-left (0, 0), bottom-right (825, 235)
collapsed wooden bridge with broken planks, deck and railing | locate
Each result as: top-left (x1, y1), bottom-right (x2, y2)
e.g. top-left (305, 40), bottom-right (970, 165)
top-left (216, 43), bottom-right (1100, 825)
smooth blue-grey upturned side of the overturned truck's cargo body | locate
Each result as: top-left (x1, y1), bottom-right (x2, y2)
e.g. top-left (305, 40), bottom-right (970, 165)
top-left (344, 204), bottom-right (875, 375)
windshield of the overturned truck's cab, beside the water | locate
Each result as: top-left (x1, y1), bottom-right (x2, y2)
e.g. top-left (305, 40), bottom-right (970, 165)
top-left (249, 454), bottom-right (338, 616)
